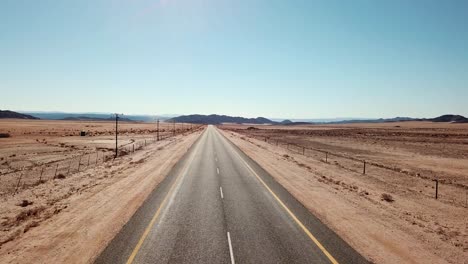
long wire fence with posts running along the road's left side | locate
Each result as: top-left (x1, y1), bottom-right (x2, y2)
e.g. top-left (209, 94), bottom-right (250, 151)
top-left (0, 126), bottom-right (201, 196)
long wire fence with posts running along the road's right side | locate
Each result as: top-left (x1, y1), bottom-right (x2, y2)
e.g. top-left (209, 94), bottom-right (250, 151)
top-left (223, 128), bottom-right (468, 208)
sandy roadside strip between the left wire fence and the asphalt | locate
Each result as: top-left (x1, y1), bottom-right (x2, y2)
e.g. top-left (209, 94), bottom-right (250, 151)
top-left (0, 127), bottom-right (201, 263)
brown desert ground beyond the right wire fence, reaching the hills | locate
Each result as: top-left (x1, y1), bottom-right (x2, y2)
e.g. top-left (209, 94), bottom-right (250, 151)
top-left (223, 122), bottom-right (468, 206)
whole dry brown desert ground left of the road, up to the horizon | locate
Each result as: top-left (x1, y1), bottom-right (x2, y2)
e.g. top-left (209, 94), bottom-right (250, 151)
top-left (0, 119), bottom-right (203, 263)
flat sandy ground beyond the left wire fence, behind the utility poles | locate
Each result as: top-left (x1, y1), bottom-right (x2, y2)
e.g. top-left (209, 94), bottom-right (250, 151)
top-left (0, 119), bottom-right (190, 172)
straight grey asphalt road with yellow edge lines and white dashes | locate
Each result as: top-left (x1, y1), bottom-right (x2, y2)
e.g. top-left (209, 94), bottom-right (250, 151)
top-left (96, 126), bottom-right (367, 264)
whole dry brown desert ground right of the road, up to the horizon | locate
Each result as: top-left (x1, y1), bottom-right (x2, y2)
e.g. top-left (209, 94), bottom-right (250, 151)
top-left (220, 121), bottom-right (468, 264)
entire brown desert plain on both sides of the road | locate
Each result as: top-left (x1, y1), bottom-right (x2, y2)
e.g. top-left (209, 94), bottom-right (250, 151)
top-left (0, 119), bottom-right (468, 264)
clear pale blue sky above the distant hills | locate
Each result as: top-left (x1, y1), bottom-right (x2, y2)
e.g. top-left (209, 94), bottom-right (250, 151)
top-left (0, 0), bottom-right (468, 118)
